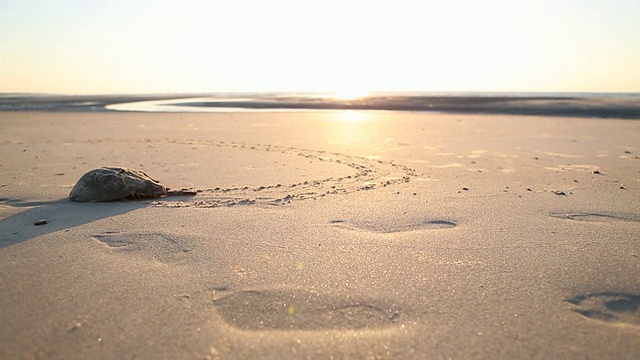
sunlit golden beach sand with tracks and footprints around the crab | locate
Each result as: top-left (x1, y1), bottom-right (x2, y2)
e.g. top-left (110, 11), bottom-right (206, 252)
top-left (0, 112), bottom-right (640, 359)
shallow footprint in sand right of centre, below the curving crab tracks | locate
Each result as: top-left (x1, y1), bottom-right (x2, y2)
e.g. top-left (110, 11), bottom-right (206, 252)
top-left (330, 217), bottom-right (458, 233)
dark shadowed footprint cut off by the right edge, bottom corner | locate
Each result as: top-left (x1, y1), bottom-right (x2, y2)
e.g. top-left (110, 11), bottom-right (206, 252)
top-left (567, 292), bottom-right (640, 327)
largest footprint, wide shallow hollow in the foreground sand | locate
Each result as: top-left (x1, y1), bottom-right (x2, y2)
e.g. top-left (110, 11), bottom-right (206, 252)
top-left (214, 290), bottom-right (402, 330)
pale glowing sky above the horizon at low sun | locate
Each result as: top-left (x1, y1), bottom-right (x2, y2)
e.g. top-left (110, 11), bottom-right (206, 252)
top-left (0, 0), bottom-right (640, 95)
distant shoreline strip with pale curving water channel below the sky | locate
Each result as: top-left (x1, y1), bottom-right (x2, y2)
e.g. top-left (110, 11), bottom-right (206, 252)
top-left (0, 93), bottom-right (640, 119)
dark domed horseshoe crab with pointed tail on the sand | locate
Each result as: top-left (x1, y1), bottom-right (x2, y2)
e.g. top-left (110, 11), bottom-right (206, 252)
top-left (69, 167), bottom-right (196, 202)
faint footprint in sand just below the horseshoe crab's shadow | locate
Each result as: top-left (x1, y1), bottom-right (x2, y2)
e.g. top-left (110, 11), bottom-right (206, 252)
top-left (93, 231), bottom-right (190, 263)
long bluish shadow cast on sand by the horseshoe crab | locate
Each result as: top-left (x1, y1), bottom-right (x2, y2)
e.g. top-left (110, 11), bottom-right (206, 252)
top-left (0, 198), bottom-right (149, 249)
